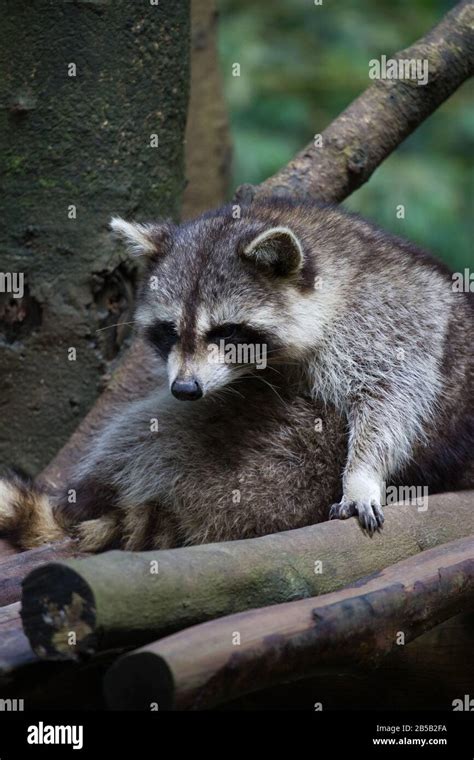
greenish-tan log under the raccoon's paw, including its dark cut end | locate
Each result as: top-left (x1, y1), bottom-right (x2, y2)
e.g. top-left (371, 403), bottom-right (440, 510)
top-left (22, 492), bottom-right (474, 658)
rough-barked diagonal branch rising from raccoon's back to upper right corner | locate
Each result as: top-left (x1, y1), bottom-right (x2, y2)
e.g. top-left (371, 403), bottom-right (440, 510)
top-left (236, 0), bottom-right (474, 202)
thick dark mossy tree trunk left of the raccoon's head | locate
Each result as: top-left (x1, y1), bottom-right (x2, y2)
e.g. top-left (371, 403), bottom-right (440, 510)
top-left (0, 0), bottom-right (189, 473)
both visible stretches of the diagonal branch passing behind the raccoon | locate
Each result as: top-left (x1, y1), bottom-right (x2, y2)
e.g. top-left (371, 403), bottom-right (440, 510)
top-left (41, 2), bottom-right (473, 483)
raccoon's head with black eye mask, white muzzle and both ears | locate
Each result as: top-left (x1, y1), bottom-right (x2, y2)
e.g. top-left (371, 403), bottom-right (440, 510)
top-left (111, 208), bottom-right (314, 400)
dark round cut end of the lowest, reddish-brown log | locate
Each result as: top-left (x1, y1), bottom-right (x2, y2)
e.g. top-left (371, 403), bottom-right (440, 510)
top-left (104, 652), bottom-right (174, 712)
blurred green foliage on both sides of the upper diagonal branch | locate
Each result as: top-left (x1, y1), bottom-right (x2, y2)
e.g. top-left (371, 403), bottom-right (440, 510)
top-left (219, 0), bottom-right (474, 270)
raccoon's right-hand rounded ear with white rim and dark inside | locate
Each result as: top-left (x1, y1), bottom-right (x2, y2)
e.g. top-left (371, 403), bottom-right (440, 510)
top-left (242, 227), bottom-right (304, 277)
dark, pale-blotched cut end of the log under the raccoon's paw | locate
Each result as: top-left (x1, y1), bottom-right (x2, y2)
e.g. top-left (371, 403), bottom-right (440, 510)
top-left (21, 563), bottom-right (98, 660)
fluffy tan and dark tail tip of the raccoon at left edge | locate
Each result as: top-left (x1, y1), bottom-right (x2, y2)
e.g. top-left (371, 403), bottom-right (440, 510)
top-left (0, 474), bottom-right (67, 549)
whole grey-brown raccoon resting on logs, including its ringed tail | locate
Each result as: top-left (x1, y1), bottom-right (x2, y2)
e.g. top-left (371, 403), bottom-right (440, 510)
top-left (0, 200), bottom-right (474, 551)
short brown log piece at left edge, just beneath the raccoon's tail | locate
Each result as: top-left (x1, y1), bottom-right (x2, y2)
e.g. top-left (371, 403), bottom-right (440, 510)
top-left (0, 539), bottom-right (85, 607)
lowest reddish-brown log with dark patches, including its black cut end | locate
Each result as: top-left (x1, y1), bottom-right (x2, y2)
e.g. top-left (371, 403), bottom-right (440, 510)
top-left (105, 536), bottom-right (474, 710)
